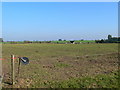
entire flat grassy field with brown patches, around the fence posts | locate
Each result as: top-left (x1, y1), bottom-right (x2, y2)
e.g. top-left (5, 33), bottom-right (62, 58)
top-left (2, 43), bottom-right (118, 88)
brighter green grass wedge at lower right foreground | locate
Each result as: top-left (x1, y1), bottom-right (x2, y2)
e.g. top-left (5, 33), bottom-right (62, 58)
top-left (47, 71), bottom-right (120, 88)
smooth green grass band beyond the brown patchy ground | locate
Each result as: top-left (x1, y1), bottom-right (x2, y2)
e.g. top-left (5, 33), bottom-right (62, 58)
top-left (2, 44), bottom-right (118, 58)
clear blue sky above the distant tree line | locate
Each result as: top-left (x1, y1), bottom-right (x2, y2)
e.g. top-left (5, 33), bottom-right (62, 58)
top-left (2, 2), bottom-right (118, 41)
